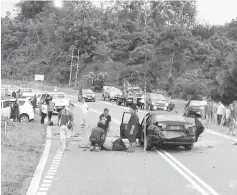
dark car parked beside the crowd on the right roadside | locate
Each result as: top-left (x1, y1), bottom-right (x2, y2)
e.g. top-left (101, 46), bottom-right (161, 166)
top-left (184, 100), bottom-right (202, 117)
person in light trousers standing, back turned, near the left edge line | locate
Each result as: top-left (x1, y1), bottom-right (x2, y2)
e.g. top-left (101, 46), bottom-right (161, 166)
top-left (58, 104), bottom-right (74, 150)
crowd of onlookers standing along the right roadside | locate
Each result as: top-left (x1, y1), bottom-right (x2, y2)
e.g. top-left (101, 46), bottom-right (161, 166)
top-left (201, 98), bottom-right (237, 135)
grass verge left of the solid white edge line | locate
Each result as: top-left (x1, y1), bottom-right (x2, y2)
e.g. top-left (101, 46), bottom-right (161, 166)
top-left (1, 116), bottom-right (46, 195)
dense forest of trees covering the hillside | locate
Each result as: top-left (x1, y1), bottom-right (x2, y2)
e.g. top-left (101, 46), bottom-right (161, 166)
top-left (1, 1), bottom-right (237, 101)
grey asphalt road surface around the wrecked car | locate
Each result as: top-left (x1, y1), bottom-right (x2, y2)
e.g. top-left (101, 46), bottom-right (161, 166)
top-left (1, 86), bottom-right (237, 195)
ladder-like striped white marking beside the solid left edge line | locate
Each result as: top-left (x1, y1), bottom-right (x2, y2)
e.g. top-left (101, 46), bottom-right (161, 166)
top-left (37, 150), bottom-right (63, 195)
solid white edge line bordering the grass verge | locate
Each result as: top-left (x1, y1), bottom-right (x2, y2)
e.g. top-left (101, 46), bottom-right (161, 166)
top-left (26, 126), bottom-right (51, 195)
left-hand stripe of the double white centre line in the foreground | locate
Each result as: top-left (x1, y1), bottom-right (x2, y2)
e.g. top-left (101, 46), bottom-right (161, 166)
top-left (157, 151), bottom-right (210, 195)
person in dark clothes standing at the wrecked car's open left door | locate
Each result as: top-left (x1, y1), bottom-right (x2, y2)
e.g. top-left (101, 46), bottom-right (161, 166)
top-left (127, 105), bottom-right (139, 152)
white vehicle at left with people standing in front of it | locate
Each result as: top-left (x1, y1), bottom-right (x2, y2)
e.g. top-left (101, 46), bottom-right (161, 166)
top-left (38, 92), bottom-right (71, 113)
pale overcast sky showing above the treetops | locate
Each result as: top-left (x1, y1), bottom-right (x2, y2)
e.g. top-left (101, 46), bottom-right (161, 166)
top-left (1, 0), bottom-right (237, 25)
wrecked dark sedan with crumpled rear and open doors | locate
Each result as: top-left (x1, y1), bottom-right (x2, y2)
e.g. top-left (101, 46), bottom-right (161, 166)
top-left (120, 112), bottom-right (204, 150)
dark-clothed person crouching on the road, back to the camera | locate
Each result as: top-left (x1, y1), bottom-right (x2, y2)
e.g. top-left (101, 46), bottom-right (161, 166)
top-left (89, 122), bottom-right (105, 152)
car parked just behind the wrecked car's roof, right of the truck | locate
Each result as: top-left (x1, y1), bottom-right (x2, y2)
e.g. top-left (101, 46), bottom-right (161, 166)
top-left (145, 93), bottom-right (174, 111)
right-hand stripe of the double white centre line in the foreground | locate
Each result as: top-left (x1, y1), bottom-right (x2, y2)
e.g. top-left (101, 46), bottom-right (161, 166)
top-left (161, 150), bottom-right (220, 195)
